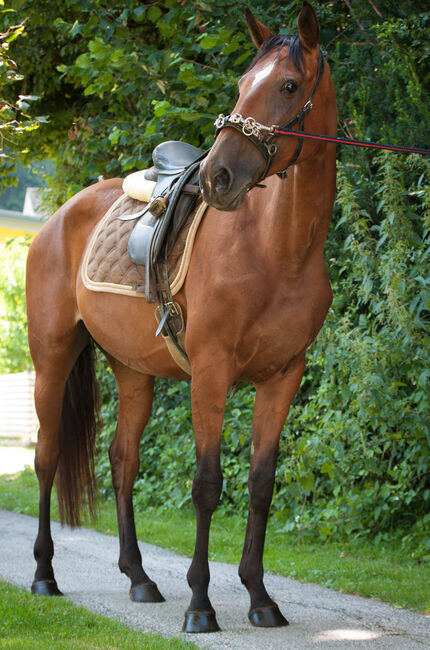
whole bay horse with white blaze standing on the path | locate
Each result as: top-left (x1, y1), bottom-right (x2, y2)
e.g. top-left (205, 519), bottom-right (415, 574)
top-left (27, 2), bottom-right (337, 632)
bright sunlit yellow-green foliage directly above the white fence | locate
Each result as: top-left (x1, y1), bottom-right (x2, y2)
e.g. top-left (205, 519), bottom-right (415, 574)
top-left (0, 238), bottom-right (32, 373)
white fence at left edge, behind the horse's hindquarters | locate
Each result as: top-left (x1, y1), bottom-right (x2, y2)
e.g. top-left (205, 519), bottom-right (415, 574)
top-left (0, 372), bottom-right (39, 442)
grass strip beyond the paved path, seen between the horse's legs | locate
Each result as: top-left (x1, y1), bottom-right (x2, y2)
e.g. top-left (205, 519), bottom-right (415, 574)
top-left (0, 469), bottom-right (430, 613)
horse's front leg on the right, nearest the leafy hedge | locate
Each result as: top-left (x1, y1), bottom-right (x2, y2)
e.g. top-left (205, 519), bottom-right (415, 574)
top-left (239, 359), bottom-right (304, 627)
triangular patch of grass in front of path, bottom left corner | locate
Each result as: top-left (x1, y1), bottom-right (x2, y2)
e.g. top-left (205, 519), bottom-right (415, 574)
top-left (0, 581), bottom-right (197, 650)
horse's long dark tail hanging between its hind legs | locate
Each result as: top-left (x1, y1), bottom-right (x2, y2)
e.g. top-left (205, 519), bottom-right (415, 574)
top-left (56, 340), bottom-right (99, 526)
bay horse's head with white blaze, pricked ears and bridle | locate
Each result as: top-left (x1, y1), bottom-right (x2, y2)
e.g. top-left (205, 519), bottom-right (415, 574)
top-left (200, 2), bottom-right (336, 210)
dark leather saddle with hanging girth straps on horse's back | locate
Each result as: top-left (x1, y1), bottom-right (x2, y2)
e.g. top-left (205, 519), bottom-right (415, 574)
top-left (119, 141), bottom-right (208, 373)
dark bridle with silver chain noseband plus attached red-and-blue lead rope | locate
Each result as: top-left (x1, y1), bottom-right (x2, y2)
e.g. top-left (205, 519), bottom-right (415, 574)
top-left (214, 50), bottom-right (430, 184)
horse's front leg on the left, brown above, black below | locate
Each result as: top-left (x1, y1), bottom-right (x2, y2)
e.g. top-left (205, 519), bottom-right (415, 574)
top-left (182, 364), bottom-right (229, 632)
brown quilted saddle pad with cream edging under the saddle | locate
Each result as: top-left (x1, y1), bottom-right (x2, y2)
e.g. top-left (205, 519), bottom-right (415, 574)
top-left (81, 194), bottom-right (207, 298)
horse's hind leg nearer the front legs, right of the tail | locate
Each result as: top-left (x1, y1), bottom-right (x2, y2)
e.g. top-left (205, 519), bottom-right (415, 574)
top-left (109, 359), bottom-right (164, 603)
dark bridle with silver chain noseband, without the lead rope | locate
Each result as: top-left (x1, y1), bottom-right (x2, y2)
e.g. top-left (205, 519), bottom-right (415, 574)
top-left (214, 50), bottom-right (324, 183)
